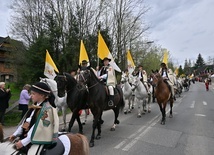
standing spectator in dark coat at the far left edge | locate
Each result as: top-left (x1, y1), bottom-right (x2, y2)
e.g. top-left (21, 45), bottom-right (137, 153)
top-left (0, 82), bottom-right (11, 125)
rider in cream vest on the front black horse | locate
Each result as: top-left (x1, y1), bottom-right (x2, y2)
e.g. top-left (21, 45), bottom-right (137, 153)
top-left (98, 57), bottom-right (117, 106)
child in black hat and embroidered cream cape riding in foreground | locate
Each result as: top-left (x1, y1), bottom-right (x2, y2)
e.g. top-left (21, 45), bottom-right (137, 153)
top-left (9, 82), bottom-right (60, 154)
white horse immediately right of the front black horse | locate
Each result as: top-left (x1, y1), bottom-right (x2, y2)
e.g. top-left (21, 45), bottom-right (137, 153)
top-left (120, 72), bottom-right (134, 114)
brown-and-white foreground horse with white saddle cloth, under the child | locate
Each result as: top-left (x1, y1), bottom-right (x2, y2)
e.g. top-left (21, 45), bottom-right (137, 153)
top-left (0, 125), bottom-right (89, 155)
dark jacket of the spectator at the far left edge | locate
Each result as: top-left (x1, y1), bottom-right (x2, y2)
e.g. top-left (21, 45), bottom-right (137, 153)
top-left (0, 89), bottom-right (11, 111)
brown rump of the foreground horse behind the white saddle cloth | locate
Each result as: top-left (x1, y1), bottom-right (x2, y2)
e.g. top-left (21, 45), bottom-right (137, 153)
top-left (67, 133), bottom-right (89, 155)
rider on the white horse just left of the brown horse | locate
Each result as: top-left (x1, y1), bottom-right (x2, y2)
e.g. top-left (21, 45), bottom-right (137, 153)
top-left (135, 65), bottom-right (151, 95)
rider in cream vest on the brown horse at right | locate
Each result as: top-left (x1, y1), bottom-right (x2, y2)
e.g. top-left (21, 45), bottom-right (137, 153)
top-left (159, 63), bottom-right (176, 100)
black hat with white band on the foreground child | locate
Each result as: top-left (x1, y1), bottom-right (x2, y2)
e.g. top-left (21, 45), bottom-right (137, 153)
top-left (31, 82), bottom-right (51, 95)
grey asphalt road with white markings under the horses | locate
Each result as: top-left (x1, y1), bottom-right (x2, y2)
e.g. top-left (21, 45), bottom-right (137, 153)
top-left (2, 82), bottom-right (214, 155)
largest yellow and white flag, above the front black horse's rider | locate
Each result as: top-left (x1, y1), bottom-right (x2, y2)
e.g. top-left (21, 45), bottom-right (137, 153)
top-left (97, 32), bottom-right (121, 72)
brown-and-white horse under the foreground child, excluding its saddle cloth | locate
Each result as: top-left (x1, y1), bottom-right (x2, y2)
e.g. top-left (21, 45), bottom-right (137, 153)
top-left (0, 124), bottom-right (89, 155)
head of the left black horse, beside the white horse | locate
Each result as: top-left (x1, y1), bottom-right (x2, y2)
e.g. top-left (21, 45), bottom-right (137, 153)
top-left (55, 75), bottom-right (67, 97)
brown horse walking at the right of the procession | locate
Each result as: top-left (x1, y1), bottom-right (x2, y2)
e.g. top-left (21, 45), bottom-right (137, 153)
top-left (151, 73), bottom-right (173, 125)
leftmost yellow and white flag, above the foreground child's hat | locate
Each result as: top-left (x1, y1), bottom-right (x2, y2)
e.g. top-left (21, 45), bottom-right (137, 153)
top-left (44, 50), bottom-right (59, 79)
